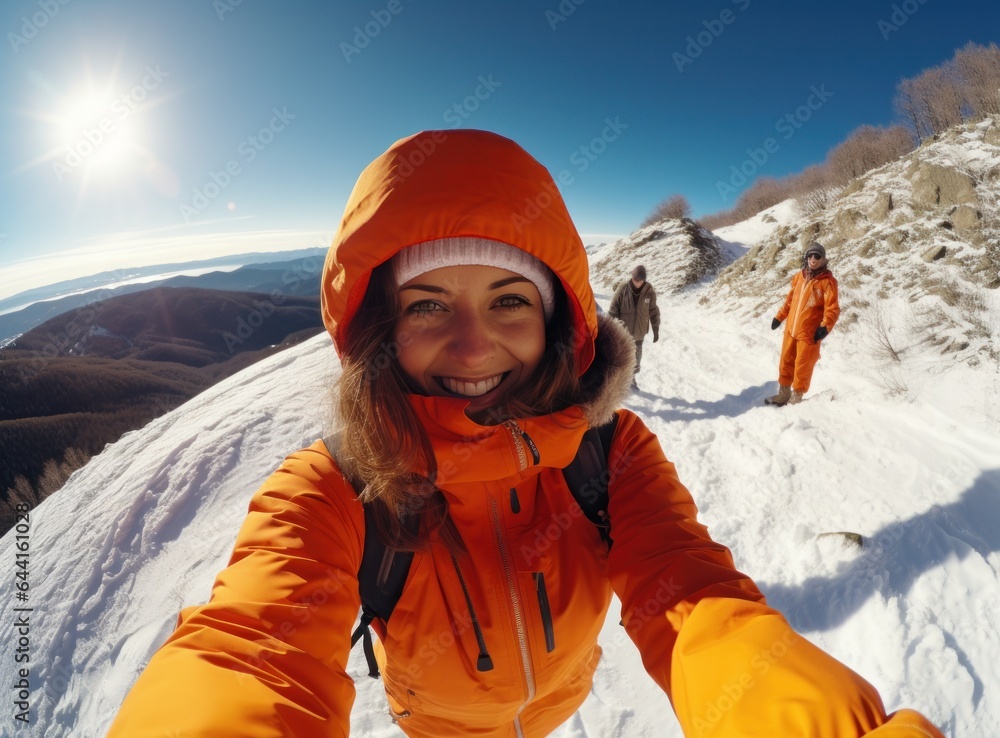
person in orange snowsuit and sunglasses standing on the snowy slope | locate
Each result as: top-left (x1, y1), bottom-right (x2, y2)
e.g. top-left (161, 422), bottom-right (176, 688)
top-left (767, 241), bottom-right (840, 405)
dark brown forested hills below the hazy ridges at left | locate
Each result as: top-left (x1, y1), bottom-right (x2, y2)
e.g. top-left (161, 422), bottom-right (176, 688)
top-left (0, 282), bottom-right (323, 531)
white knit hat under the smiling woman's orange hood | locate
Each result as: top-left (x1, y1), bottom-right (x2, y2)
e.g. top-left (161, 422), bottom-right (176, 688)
top-left (392, 236), bottom-right (556, 323)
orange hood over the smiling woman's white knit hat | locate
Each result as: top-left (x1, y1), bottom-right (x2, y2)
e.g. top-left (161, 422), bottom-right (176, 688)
top-left (322, 129), bottom-right (597, 374)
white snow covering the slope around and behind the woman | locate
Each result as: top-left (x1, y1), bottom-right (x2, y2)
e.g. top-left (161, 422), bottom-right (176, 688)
top-left (0, 239), bottom-right (1000, 738)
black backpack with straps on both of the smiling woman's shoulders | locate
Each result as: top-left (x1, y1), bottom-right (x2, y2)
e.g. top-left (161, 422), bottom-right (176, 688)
top-left (323, 413), bottom-right (618, 679)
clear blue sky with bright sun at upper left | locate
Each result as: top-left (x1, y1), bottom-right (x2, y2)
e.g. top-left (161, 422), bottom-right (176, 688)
top-left (0, 0), bottom-right (1000, 294)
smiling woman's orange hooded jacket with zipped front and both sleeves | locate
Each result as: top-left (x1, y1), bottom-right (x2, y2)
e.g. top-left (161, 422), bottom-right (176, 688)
top-left (110, 131), bottom-right (940, 738)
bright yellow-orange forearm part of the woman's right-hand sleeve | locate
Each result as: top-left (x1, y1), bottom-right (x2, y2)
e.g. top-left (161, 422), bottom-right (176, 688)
top-left (672, 599), bottom-right (944, 738)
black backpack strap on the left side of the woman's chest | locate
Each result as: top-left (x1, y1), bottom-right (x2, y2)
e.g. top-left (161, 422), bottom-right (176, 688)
top-left (323, 432), bottom-right (420, 679)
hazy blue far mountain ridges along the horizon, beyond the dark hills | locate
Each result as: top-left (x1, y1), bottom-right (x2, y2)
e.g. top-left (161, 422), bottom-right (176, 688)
top-left (0, 249), bottom-right (325, 347)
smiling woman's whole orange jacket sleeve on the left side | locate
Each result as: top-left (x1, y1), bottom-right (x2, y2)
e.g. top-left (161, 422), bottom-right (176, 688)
top-left (108, 442), bottom-right (364, 738)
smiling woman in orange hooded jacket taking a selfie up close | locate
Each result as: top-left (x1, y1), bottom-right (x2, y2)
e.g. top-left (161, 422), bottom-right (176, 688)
top-left (109, 130), bottom-right (943, 738)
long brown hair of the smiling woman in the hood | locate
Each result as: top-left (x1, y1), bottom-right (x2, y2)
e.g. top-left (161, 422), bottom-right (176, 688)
top-left (337, 262), bottom-right (589, 550)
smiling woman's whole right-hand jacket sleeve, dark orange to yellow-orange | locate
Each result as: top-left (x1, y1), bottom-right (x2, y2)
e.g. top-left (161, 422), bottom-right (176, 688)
top-left (608, 411), bottom-right (943, 738)
